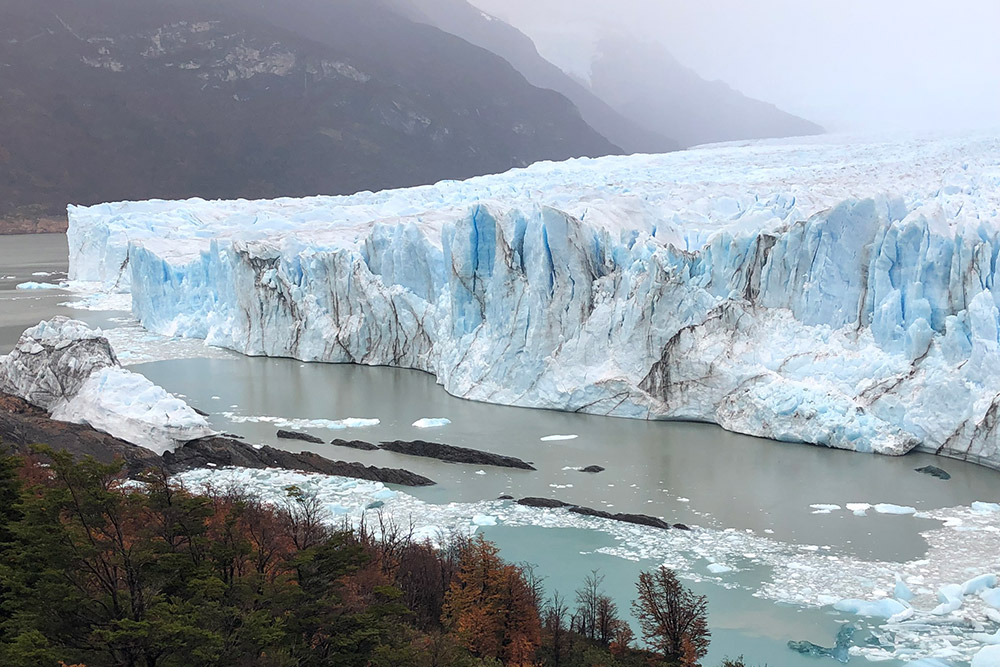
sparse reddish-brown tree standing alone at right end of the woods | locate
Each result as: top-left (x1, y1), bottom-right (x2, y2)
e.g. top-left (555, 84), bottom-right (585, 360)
top-left (632, 565), bottom-right (711, 667)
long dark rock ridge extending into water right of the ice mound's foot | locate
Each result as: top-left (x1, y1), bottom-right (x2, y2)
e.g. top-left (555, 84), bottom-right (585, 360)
top-left (163, 437), bottom-right (434, 486)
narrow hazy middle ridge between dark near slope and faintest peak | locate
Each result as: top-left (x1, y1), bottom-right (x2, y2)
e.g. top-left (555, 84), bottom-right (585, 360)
top-left (393, 0), bottom-right (678, 153)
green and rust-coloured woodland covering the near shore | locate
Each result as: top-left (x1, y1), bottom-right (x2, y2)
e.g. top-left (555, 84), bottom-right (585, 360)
top-left (0, 447), bottom-right (743, 667)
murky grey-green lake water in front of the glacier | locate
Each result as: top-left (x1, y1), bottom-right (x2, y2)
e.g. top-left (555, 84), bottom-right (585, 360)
top-left (0, 235), bottom-right (1000, 667)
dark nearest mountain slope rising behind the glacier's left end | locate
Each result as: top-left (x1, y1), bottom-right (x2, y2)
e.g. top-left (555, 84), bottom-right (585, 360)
top-left (0, 0), bottom-right (620, 226)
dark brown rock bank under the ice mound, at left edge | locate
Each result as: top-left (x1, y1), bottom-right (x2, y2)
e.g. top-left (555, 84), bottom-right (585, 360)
top-left (0, 394), bottom-right (160, 475)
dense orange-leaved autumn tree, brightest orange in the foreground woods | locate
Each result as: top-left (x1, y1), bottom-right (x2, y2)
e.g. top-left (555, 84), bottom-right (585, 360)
top-left (443, 535), bottom-right (541, 666)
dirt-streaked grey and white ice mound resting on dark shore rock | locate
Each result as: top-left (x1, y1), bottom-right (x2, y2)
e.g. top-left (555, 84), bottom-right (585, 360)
top-left (0, 316), bottom-right (216, 454)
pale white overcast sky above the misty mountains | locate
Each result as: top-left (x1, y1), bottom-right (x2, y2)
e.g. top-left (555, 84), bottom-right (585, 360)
top-left (472, 0), bottom-right (1000, 131)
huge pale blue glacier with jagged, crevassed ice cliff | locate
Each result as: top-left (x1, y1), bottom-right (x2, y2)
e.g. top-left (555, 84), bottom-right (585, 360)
top-left (68, 135), bottom-right (1000, 467)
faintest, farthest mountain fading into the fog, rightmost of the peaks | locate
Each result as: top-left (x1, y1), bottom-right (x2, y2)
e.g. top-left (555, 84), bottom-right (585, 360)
top-left (590, 36), bottom-right (823, 146)
